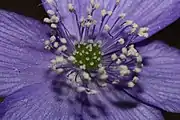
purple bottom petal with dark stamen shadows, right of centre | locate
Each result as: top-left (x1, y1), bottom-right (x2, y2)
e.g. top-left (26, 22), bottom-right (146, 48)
top-left (83, 84), bottom-right (163, 120)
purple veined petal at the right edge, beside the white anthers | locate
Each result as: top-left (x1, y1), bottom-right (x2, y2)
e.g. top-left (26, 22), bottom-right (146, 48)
top-left (129, 42), bottom-right (180, 112)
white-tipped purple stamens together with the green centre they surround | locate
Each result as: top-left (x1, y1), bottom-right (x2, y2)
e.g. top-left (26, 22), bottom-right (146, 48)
top-left (44, 0), bottom-right (149, 94)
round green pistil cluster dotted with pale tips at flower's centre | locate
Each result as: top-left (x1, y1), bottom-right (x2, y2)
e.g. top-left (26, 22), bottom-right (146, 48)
top-left (73, 43), bottom-right (102, 69)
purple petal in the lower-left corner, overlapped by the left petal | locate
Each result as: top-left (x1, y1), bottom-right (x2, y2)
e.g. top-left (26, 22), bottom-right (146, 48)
top-left (2, 83), bottom-right (73, 120)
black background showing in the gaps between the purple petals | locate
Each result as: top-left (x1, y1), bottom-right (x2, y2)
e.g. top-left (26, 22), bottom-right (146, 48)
top-left (0, 0), bottom-right (180, 120)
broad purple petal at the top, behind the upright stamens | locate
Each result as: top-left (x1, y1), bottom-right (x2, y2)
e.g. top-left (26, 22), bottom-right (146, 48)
top-left (42, 0), bottom-right (180, 42)
